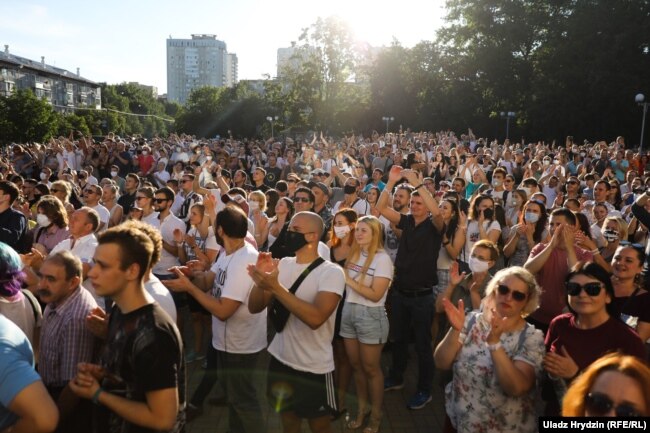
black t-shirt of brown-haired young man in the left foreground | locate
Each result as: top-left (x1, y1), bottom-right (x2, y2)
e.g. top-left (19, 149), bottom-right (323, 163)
top-left (95, 303), bottom-right (185, 433)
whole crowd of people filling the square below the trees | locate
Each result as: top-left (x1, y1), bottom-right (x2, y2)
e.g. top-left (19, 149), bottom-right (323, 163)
top-left (0, 130), bottom-right (650, 433)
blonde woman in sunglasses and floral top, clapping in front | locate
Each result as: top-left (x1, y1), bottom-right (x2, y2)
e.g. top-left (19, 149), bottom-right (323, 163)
top-left (434, 266), bottom-right (544, 433)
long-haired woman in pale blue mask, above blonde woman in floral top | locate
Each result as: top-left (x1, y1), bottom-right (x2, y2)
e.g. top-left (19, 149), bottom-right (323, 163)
top-left (503, 200), bottom-right (548, 266)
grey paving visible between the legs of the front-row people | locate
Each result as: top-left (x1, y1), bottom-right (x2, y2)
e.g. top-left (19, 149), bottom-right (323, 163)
top-left (182, 346), bottom-right (445, 433)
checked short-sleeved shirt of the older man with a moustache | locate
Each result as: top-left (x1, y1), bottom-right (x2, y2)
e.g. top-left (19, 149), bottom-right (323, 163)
top-left (38, 286), bottom-right (97, 386)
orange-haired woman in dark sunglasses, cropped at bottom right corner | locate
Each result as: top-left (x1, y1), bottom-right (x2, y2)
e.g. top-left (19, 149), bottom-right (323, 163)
top-left (562, 353), bottom-right (650, 417)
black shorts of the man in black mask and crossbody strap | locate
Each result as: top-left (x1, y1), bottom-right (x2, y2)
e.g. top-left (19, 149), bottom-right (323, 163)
top-left (266, 356), bottom-right (337, 419)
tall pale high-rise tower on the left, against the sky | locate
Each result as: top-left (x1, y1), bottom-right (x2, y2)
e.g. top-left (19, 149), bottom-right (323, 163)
top-left (167, 34), bottom-right (237, 104)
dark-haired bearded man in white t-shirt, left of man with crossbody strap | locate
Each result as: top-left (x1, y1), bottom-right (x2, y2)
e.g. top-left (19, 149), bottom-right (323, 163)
top-left (165, 206), bottom-right (266, 433)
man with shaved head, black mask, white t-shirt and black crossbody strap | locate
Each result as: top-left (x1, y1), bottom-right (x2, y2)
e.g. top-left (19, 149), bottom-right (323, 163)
top-left (248, 212), bottom-right (345, 432)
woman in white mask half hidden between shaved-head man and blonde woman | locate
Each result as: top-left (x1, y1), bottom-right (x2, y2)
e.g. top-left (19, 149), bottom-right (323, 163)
top-left (328, 208), bottom-right (358, 422)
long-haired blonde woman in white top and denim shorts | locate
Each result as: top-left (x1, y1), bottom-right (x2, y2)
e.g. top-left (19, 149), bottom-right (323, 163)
top-left (340, 216), bottom-right (393, 433)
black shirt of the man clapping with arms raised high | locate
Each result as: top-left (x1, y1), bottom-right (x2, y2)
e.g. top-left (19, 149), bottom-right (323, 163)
top-left (393, 214), bottom-right (442, 292)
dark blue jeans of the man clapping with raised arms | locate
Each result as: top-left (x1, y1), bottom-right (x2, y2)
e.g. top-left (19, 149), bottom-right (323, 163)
top-left (389, 290), bottom-right (434, 393)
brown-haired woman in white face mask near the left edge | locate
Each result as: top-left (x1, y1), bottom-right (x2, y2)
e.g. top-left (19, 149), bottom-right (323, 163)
top-left (33, 196), bottom-right (70, 255)
